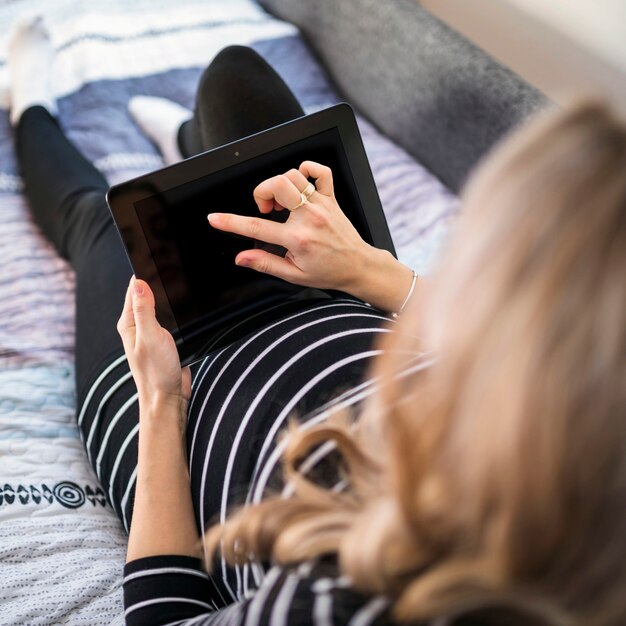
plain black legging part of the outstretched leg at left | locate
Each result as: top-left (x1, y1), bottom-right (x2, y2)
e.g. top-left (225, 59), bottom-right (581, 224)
top-left (16, 106), bottom-right (131, 390)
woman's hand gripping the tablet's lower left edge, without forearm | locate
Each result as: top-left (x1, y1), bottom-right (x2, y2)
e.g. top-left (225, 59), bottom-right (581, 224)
top-left (117, 276), bottom-right (191, 418)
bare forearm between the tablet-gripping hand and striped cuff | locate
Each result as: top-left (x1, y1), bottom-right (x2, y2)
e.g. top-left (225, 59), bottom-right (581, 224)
top-left (127, 403), bottom-right (202, 561)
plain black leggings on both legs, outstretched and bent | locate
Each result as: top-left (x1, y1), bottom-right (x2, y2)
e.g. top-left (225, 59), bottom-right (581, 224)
top-left (16, 46), bottom-right (304, 410)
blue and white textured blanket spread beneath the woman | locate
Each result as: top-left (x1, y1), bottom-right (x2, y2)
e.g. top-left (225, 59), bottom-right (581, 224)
top-left (0, 0), bottom-right (457, 626)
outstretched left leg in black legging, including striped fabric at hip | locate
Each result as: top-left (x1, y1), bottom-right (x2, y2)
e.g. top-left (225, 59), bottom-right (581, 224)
top-left (16, 107), bottom-right (138, 524)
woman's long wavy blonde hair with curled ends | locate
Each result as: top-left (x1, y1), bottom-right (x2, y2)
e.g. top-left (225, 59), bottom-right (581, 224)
top-left (205, 104), bottom-right (626, 626)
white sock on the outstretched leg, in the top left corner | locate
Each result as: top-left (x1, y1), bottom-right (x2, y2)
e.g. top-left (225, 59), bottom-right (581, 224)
top-left (7, 16), bottom-right (56, 126)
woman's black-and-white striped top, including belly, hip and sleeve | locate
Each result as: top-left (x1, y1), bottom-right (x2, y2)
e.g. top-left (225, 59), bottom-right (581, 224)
top-left (79, 298), bottom-right (424, 626)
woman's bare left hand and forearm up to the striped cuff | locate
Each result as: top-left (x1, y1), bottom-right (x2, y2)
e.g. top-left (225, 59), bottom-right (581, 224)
top-left (117, 276), bottom-right (202, 561)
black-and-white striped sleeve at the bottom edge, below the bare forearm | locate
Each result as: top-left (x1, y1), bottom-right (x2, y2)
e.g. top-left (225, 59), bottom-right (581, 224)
top-left (124, 555), bottom-right (391, 626)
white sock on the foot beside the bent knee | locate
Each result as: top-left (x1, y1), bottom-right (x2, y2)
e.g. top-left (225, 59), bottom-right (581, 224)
top-left (128, 96), bottom-right (193, 165)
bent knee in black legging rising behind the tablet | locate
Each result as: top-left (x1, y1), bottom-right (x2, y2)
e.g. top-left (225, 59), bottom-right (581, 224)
top-left (178, 46), bottom-right (304, 158)
